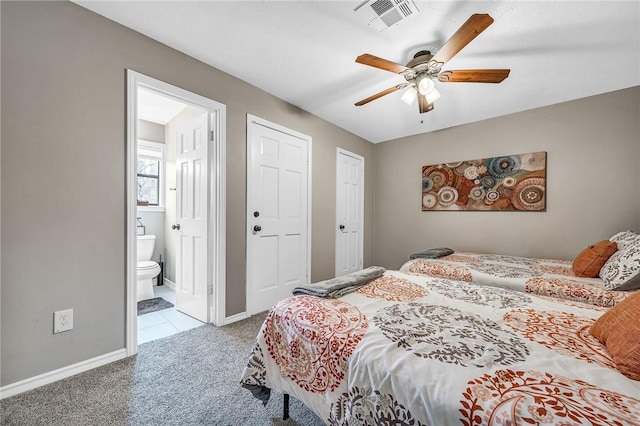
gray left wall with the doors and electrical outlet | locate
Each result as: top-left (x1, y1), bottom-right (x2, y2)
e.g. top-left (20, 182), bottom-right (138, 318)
top-left (0, 2), bottom-right (374, 385)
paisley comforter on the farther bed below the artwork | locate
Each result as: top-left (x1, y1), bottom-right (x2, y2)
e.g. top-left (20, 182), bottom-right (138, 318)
top-left (400, 252), bottom-right (631, 307)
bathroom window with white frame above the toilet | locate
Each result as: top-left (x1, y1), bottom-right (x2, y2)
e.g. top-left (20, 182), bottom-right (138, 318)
top-left (137, 140), bottom-right (164, 209)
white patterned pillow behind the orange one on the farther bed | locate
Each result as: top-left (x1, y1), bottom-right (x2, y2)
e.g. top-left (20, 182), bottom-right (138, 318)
top-left (600, 241), bottom-right (640, 290)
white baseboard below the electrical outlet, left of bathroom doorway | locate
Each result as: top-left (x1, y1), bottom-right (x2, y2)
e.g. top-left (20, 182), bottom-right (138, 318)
top-left (0, 349), bottom-right (127, 399)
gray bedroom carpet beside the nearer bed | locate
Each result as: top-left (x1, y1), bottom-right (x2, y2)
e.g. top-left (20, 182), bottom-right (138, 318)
top-left (0, 314), bottom-right (324, 426)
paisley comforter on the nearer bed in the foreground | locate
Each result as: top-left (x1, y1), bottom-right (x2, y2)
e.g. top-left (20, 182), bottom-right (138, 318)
top-left (241, 271), bottom-right (640, 426)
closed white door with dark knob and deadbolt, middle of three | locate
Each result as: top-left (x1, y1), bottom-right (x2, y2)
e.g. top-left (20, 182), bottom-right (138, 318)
top-left (247, 116), bottom-right (311, 315)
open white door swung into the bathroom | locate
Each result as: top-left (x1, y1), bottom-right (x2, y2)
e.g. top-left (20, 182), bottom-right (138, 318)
top-left (172, 113), bottom-right (211, 322)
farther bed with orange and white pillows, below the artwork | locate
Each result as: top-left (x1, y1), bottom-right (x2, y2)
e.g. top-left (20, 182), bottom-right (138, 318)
top-left (400, 231), bottom-right (640, 307)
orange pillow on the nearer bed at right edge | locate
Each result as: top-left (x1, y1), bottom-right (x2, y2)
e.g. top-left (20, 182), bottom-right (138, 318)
top-left (589, 291), bottom-right (640, 380)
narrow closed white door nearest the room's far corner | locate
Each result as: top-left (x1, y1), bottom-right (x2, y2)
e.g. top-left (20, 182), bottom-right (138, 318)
top-left (336, 148), bottom-right (364, 277)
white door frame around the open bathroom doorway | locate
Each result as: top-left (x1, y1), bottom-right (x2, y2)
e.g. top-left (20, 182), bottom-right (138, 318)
top-left (125, 69), bottom-right (227, 356)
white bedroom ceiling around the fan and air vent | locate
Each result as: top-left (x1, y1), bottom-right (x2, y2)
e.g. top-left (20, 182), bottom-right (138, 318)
top-left (76, 0), bottom-right (640, 142)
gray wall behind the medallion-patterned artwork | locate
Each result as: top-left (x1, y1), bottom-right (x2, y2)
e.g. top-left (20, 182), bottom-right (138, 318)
top-left (374, 87), bottom-right (640, 268)
